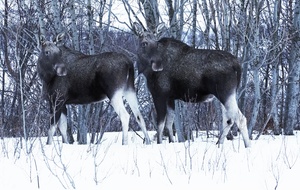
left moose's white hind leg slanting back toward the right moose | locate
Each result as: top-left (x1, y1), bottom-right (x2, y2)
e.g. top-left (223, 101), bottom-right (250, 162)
top-left (125, 90), bottom-right (151, 144)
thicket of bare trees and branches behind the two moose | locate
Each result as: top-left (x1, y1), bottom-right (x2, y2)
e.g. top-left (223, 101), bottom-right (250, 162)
top-left (0, 0), bottom-right (300, 143)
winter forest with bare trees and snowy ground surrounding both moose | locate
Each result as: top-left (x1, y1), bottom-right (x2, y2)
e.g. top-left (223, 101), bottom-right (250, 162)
top-left (0, 0), bottom-right (300, 189)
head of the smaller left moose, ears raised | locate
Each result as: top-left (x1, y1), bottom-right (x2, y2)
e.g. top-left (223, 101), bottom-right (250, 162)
top-left (39, 33), bottom-right (67, 76)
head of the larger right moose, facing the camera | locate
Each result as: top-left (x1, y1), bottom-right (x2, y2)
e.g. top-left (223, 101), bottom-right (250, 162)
top-left (133, 22), bottom-right (165, 73)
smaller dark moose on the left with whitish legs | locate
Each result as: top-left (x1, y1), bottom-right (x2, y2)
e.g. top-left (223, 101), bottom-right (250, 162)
top-left (37, 33), bottom-right (151, 145)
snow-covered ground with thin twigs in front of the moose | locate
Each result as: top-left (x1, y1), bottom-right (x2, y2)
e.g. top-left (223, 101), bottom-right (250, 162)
top-left (0, 132), bottom-right (300, 190)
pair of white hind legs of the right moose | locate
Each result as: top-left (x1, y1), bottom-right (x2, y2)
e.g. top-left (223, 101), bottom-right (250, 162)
top-left (219, 93), bottom-right (250, 148)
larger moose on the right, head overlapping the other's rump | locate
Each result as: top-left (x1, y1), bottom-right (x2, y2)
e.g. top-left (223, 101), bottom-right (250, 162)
top-left (133, 22), bottom-right (250, 147)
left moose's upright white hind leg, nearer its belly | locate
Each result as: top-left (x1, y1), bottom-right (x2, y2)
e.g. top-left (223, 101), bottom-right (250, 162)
top-left (110, 90), bottom-right (130, 145)
